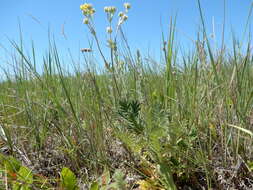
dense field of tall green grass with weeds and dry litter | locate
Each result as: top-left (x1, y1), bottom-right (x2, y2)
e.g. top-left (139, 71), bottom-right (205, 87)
top-left (0, 1), bottom-right (253, 190)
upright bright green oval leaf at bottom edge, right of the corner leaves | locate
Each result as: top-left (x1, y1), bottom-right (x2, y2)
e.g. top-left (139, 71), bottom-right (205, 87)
top-left (61, 167), bottom-right (77, 190)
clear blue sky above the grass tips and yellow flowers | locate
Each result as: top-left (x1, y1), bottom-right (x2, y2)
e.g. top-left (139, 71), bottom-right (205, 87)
top-left (0, 0), bottom-right (253, 69)
